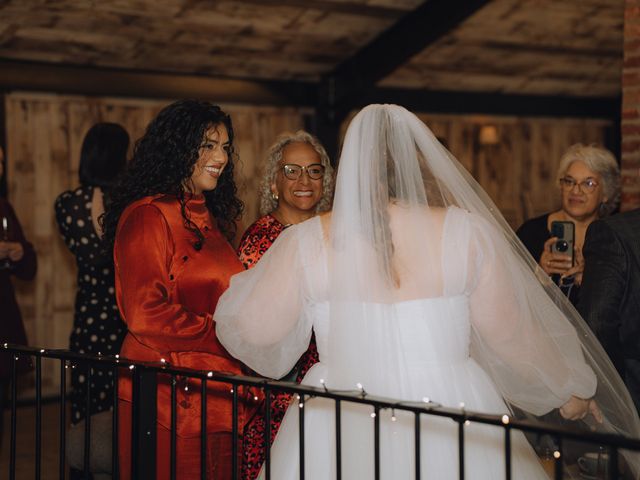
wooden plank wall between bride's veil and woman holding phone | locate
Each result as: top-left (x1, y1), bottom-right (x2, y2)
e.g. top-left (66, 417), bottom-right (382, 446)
top-left (419, 113), bottom-right (612, 228)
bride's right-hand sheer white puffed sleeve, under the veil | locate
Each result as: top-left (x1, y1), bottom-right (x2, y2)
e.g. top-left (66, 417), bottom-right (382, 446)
top-left (450, 210), bottom-right (597, 415)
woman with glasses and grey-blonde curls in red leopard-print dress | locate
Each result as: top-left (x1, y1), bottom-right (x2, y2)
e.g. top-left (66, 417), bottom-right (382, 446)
top-left (238, 130), bottom-right (333, 480)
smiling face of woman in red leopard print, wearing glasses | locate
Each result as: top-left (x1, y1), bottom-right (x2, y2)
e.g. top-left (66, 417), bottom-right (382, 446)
top-left (271, 142), bottom-right (323, 223)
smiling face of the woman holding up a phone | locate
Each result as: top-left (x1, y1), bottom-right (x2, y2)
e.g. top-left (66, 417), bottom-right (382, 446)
top-left (562, 160), bottom-right (606, 220)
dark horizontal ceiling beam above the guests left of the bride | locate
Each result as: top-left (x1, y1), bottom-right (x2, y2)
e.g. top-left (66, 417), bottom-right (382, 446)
top-left (0, 58), bottom-right (316, 106)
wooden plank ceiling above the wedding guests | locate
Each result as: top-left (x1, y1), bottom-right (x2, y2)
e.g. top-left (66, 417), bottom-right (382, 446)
top-left (0, 0), bottom-right (624, 104)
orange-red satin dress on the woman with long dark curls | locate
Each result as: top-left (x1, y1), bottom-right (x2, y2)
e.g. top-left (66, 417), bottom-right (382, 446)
top-left (114, 195), bottom-right (256, 478)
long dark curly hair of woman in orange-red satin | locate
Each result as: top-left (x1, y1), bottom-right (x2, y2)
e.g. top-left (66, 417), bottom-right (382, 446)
top-left (102, 100), bottom-right (244, 251)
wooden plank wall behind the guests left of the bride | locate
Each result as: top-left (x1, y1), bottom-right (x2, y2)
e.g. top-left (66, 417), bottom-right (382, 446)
top-left (5, 92), bottom-right (308, 387)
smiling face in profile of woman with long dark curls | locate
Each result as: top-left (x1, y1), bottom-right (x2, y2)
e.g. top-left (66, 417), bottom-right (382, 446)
top-left (190, 124), bottom-right (230, 195)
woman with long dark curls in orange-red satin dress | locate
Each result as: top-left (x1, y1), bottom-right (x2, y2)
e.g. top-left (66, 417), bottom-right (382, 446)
top-left (104, 100), bottom-right (254, 479)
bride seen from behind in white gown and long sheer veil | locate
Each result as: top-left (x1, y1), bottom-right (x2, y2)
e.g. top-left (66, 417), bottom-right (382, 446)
top-left (215, 105), bottom-right (640, 480)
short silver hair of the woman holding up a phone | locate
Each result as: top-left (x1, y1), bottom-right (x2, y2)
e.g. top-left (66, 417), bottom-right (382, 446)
top-left (557, 143), bottom-right (620, 217)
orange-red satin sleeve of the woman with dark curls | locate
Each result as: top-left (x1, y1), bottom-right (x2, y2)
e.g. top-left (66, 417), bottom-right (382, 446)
top-left (114, 205), bottom-right (215, 352)
